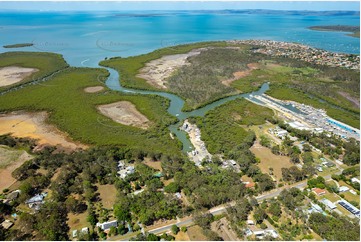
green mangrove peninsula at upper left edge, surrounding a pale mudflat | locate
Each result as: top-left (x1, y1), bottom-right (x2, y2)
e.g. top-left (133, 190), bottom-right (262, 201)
top-left (0, 52), bottom-right (68, 92)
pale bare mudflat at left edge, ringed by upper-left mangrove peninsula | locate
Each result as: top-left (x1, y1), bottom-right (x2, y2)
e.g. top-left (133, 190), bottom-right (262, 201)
top-left (0, 66), bottom-right (39, 87)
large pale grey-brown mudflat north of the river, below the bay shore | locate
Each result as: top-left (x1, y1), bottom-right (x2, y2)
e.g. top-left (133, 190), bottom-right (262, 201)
top-left (137, 48), bottom-right (206, 89)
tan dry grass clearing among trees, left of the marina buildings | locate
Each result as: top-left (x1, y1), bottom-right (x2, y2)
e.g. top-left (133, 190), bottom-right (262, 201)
top-left (251, 142), bottom-right (292, 180)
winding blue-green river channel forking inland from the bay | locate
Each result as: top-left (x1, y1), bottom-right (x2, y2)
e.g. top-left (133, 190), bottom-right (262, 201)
top-left (101, 67), bottom-right (269, 152)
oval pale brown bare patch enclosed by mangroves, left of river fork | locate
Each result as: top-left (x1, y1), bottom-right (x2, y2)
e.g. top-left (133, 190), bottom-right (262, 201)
top-left (98, 101), bottom-right (150, 129)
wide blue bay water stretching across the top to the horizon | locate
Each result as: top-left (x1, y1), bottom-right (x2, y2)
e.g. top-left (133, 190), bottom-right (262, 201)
top-left (0, 11), bottom-right (360, 67)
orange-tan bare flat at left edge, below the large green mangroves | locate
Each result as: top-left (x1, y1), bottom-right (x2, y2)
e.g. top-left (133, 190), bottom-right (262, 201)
top-left (0, 112), bottom-right (87, 150)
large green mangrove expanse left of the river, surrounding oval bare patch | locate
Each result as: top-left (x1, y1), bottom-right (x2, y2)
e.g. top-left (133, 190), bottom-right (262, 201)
top-left (0, 68), bottom-right (180, 154)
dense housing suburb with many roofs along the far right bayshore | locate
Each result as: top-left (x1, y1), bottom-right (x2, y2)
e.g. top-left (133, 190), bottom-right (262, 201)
top-left (232, 40), bottom-right (360, 70)
